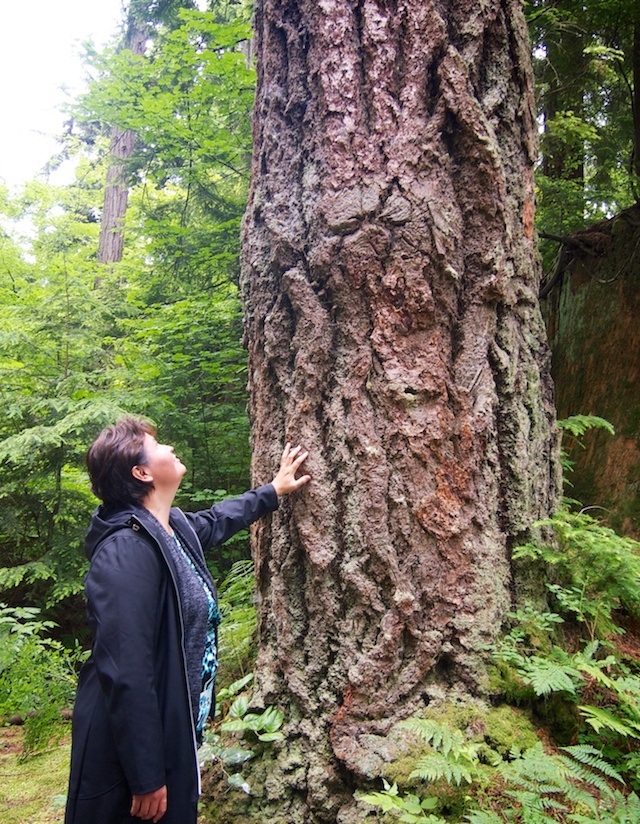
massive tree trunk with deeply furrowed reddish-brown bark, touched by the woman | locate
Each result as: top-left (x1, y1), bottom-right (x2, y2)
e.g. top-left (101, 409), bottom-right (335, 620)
top-left (243, 0), bottom-right (558, 824)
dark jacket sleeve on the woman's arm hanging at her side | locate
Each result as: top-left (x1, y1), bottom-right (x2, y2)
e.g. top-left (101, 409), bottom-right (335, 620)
top-left (85, 530), bottom-right (166, 795)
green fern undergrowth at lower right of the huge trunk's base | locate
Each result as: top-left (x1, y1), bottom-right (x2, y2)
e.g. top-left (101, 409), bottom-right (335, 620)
top-left (357, 416), bottom-right (640, 824)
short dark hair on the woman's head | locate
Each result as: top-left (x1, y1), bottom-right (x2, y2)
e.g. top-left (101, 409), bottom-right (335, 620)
top-left (87, 416), bottom-right (156, 504)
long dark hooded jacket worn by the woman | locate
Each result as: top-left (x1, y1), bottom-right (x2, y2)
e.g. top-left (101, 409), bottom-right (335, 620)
top-left (65, 484), bottom-right (278, 824)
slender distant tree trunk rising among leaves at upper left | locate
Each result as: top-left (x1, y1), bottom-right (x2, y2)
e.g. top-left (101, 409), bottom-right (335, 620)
top-left (98, 25), bottom-right (149, 264)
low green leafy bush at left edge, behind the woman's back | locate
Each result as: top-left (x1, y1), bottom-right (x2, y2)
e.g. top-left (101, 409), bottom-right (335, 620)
top-left (0, 604), bottom-right (83, 757)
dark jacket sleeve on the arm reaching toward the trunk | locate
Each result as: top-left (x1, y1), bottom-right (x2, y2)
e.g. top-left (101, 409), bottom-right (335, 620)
top-left (185, 484), bottom-right (278, 550)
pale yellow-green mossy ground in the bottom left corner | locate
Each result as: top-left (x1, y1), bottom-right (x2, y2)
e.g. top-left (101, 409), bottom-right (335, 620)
top-left (0, 727), bottom-right (70, 824)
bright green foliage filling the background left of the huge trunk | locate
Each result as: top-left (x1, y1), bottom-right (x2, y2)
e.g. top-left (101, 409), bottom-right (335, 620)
top-left (0, 3), bottom-right (254, 621)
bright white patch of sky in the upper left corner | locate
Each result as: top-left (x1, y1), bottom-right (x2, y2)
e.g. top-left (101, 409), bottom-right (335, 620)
top-left (0, 0), bottom-right (123, 188)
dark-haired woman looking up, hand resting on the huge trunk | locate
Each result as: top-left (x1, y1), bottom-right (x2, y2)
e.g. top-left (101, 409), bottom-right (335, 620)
top-left (65, 417), bottom-right (309, 824)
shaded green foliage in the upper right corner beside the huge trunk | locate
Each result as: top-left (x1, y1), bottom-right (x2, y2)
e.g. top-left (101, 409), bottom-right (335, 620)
top-left (526, 0), bottom-right (638, 270)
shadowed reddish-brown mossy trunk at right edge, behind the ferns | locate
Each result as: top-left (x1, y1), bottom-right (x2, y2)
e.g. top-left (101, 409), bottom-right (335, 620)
top-left (545, 206), bottom-right (640, 539)
